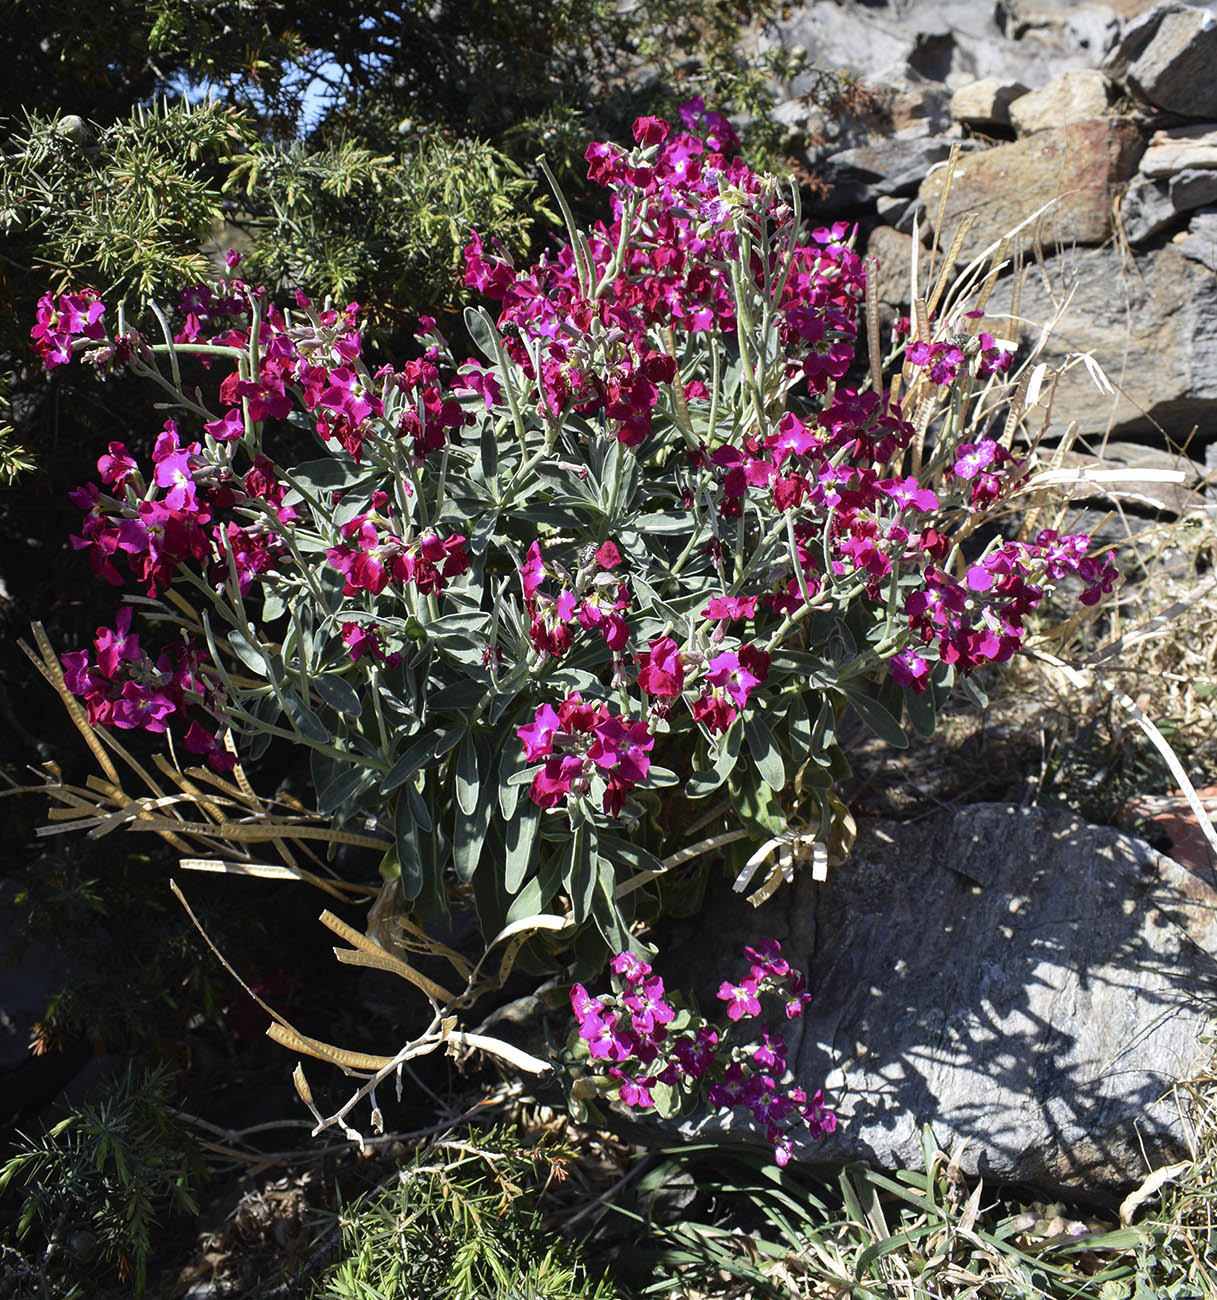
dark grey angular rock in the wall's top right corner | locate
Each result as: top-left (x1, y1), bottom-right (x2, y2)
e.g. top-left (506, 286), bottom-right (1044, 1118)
top-left (1110, 0), bottom-right (1217, 117)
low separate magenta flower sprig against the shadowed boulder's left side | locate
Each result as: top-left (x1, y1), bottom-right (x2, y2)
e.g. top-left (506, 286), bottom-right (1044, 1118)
top-left (571, 939), bottom-right (836, 1165)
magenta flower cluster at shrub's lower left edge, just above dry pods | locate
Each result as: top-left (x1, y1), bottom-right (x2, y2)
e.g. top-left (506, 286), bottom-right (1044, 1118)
top-left (62, 606), bottom-right (235, 772)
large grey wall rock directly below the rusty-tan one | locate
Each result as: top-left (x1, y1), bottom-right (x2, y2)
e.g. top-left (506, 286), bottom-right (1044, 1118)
top-left (986, 243), bottom-right (1217, 443)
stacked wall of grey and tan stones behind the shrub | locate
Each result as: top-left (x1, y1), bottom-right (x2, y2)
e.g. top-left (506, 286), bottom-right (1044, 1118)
top-left (766, 0), bottom-right (1217, 447)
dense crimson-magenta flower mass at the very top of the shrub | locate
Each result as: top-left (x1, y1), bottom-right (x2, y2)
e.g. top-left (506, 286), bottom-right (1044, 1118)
top-left (465, 100), bottom-right (866, 447)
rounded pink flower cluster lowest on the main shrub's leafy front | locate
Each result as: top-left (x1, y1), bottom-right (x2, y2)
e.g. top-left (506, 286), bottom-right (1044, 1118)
top-left (516, 692), bottom-right (655, 816)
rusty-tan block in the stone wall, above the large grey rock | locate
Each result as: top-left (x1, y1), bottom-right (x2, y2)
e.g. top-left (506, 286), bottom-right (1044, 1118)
top-left (921, 118), bottom-right (1142, 263)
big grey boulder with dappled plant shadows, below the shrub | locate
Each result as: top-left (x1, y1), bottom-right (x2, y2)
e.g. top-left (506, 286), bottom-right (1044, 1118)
top-left (668, 803), bottom-right (1217, 1191)
